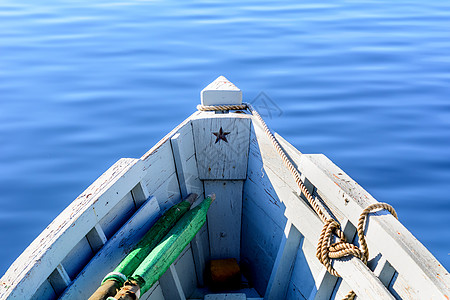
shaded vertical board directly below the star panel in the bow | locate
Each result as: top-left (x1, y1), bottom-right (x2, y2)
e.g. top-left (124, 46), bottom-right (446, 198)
top-left (204, 180), bottom-right (243, 261)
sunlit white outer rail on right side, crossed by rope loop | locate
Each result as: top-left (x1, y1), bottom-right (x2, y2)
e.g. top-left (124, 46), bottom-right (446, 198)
top-left (299, 155), bottom-right (450, 299)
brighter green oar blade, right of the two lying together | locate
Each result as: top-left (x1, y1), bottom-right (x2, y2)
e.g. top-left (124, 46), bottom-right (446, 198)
top-left (129, 194), bottom-right (215, 295)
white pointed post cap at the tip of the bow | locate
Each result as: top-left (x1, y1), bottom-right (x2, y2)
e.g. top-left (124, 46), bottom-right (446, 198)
top-left (200, 76), bottom-right (242, 105)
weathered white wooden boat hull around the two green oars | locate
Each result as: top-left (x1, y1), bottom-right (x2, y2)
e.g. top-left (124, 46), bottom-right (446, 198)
top-left (0, 78), bottom-right (450, 300)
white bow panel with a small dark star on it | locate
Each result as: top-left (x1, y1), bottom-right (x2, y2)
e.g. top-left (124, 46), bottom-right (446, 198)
top-left (192, 114), bottom-right (250, 180)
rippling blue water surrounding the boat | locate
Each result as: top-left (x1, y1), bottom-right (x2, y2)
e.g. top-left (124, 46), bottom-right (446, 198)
top-left (0, 0), bottom-right (450, 275)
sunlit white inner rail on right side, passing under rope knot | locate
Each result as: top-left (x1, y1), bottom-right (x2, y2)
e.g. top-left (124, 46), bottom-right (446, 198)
top-left (246, 119), bottom-right (391, 299)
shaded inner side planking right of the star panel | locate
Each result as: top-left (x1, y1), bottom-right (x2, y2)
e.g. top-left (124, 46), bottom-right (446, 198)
top-left (241, 130), bottom-right (287, 295)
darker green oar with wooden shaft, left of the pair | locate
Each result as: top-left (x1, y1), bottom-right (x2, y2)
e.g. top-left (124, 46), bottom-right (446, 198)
top-left (89, 194), bottom-right (197, 300)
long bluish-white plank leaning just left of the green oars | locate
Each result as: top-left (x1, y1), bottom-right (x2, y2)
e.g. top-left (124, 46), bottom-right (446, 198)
top-left (61, 198), bottom-right (160, 299)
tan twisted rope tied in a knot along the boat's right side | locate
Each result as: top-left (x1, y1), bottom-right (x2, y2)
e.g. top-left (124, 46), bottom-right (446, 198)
top-left (197, 103), bottom-right (397, 300)
